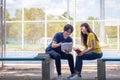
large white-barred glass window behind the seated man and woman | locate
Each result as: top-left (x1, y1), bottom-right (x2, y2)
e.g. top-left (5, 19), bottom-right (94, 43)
top-left (6, 0), bottom-right (120, 51)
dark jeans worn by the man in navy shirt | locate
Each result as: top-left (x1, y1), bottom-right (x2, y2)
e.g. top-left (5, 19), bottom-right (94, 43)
top-left (46, 49), bottom-right (74, 75)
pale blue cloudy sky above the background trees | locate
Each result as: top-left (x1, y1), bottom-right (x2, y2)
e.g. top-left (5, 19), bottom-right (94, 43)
top-left (6, 0), bottom-right (120, 20)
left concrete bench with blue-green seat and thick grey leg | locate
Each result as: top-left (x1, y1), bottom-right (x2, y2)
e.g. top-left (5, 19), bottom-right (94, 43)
top-left (0, 53), bottom-right (54, 80)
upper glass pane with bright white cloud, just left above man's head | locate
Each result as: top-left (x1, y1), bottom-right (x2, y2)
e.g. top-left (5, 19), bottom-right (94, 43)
top-left (46, 0), bottom-right (68, 20)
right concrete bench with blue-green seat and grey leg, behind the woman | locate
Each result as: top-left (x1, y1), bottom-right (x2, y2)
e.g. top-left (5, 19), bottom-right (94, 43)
top-left (97, 58), bottom-right (120, 80)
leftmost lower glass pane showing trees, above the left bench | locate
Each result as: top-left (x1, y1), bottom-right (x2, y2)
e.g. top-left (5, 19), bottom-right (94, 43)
top-left (6, 22), bottom-right (22, 50)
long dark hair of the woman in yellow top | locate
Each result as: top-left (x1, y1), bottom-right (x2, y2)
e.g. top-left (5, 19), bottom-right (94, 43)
top-left (80, 23), bottom-right (99, 47)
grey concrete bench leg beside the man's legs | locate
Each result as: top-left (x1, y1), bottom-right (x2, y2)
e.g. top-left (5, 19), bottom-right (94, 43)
top-left (42, 59), bottom-right (54, 80)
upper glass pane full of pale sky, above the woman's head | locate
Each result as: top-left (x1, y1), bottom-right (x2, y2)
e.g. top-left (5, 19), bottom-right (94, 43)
top-left (76, 0), bottom-right (100, 20)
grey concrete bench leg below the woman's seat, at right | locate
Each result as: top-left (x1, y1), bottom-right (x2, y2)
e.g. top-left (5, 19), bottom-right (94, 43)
top-left (97, 59), bottom-right (106, 80)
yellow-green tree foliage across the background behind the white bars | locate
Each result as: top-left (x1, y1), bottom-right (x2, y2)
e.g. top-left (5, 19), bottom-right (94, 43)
top-left (6, 8), bottom-right (117, 48)
